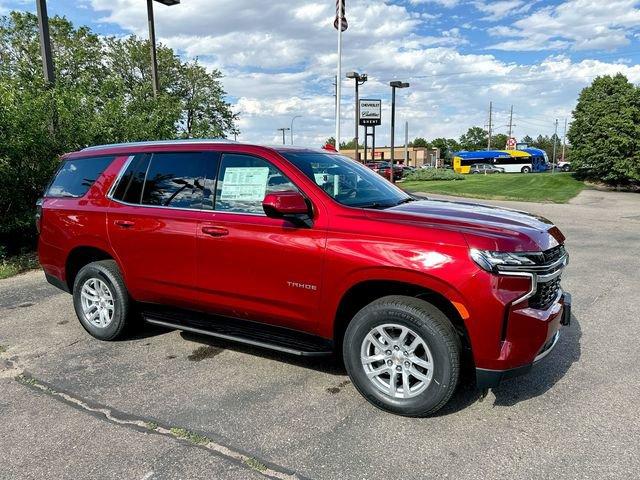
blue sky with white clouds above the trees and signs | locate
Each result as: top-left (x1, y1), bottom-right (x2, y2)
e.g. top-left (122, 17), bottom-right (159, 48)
top-left (0, 0), bottom-right (640, 145)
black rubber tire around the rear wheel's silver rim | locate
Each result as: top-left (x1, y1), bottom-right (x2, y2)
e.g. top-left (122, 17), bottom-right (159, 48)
top-left (73, 260), bottom-right (132, 341)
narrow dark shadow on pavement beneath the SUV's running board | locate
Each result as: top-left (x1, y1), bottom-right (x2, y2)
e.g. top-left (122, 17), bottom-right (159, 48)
top-left (180, 332), bottom-right (347, 377)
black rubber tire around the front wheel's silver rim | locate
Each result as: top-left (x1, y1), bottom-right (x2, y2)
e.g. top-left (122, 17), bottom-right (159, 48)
top-left (343, 295), bottom-right (461, 417)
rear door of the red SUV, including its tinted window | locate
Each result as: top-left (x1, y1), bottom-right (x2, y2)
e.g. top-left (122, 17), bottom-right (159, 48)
top-left (107, 152), bottom-right (216, 307)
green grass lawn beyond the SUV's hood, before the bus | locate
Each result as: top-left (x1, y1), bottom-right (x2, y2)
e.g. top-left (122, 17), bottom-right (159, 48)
top-left (398, 173), bottom-right (584, 203)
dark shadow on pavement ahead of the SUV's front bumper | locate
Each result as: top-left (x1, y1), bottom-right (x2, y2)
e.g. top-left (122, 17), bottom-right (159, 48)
top-left (493, 315), bottom-right (582, 407)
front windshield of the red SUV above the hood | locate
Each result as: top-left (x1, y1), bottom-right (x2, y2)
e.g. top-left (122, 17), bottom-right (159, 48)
top-left (280, 152), bottom-right (412, 208)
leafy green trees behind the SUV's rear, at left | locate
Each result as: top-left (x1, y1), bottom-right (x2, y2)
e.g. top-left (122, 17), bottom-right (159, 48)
top-left (0, 12), bottom-right (237, 254)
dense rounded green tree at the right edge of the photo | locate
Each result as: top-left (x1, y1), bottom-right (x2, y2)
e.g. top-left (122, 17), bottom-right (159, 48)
top-left (568, 74), bottom-right (640, 185)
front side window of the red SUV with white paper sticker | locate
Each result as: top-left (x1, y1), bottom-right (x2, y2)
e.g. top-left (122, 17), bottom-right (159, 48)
top-left (215, 153), bottom-right (298, 215)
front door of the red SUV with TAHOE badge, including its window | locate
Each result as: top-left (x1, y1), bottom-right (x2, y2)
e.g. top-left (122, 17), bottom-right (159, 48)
top-left (198, 153), bottom-right (326, 331)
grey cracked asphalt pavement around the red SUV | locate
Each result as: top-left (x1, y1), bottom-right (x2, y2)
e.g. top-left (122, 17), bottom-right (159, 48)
top-left (0, 190), bottom-right (640, 480)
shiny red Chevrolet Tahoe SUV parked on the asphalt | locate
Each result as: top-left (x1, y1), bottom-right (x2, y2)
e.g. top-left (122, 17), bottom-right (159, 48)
top-left (37, 140), bottom-right (570, 416)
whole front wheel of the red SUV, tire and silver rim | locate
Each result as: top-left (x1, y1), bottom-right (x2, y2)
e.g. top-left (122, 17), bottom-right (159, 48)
top-left (343, 296), bottom-right (460, 417)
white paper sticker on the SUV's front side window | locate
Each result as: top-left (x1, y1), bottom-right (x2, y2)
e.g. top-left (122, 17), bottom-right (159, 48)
top-left (220, 167), bottom-right (269, 202)
